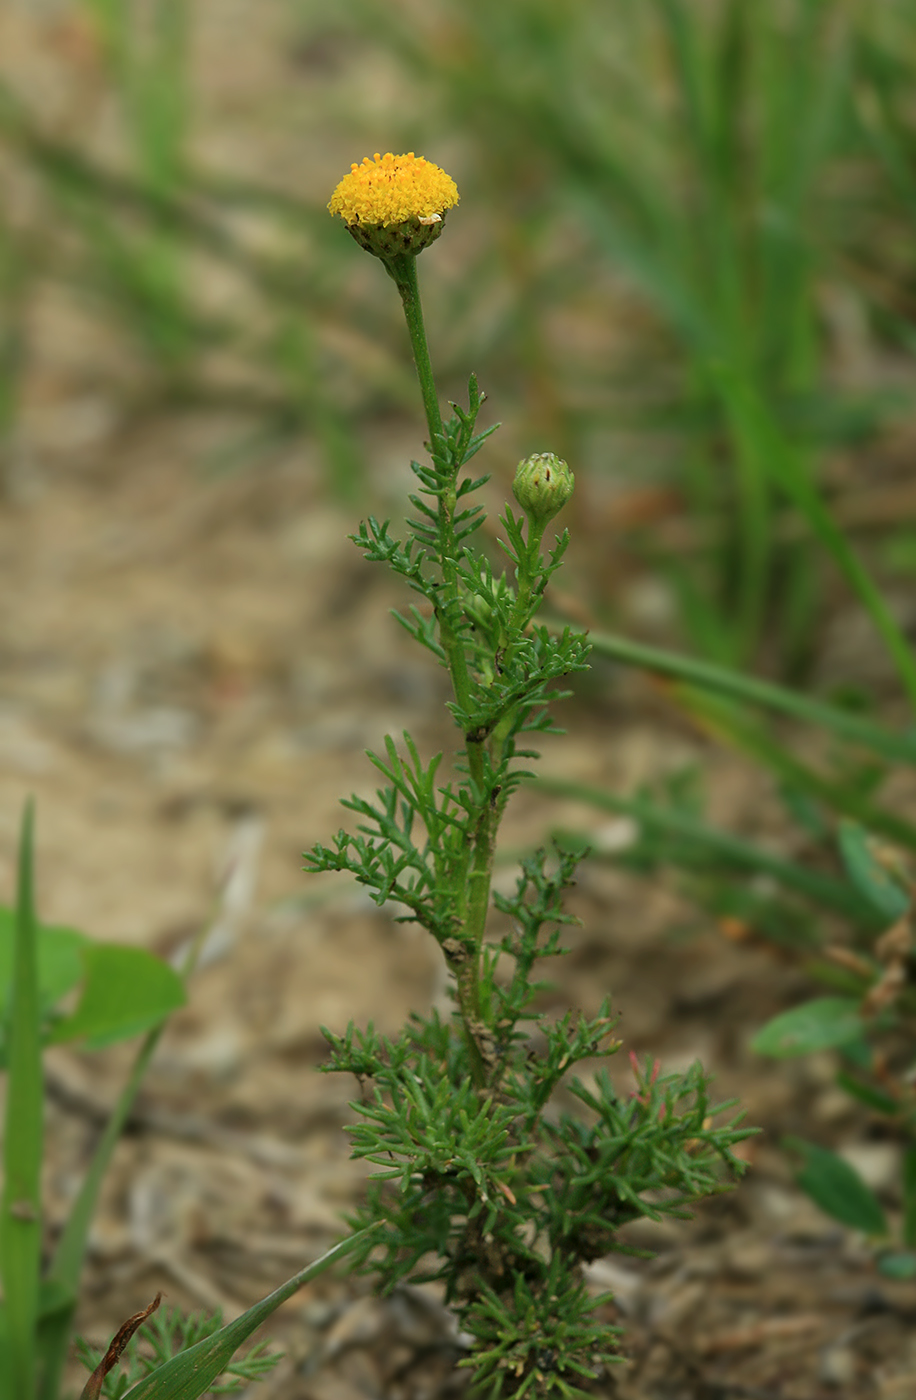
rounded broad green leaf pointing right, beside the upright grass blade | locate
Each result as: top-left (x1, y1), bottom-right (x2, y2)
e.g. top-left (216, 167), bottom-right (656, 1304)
top-left (50, 942), bottom-right (185, 1049)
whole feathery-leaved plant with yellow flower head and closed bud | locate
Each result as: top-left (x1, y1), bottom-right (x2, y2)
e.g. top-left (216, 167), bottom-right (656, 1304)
top-left (307, 154), bottom-right (748, 1400)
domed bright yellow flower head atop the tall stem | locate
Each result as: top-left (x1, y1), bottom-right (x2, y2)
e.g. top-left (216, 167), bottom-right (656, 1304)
top-left (328, 151), bottom-right (458, 258)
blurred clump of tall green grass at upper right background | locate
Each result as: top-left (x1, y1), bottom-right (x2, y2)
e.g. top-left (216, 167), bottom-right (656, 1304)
top-left (340, 0), bottom-right (913, 672)
